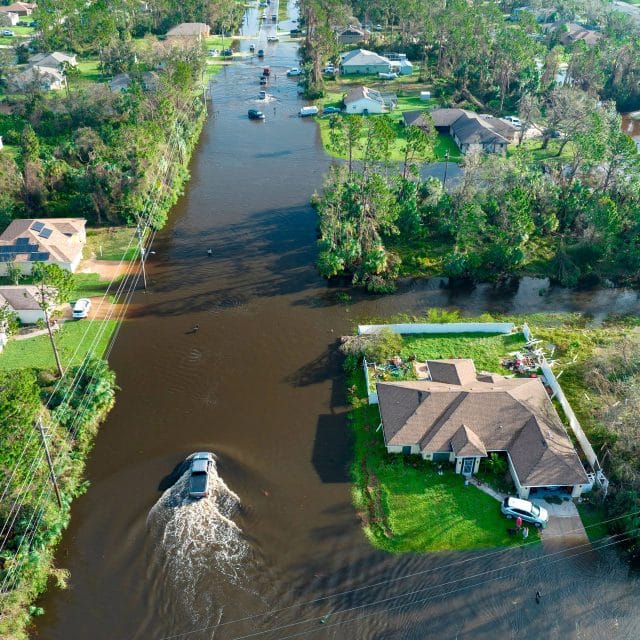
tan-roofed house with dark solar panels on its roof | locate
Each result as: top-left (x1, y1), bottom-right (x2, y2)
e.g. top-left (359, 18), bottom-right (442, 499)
top-left (0, 218), bottom-right (87, 275)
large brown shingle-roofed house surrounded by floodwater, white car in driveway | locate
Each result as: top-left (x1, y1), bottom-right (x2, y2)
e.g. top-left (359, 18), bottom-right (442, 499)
top-left (377, 359), bottom-right (589, 498)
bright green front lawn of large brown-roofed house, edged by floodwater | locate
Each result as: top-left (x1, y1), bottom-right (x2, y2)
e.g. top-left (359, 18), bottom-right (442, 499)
top-left (348, 371), bottom-right (539, 553)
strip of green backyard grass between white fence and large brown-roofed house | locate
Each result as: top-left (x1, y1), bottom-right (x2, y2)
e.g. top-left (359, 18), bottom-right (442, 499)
top-left (400, 333), bottom-right (525, 373)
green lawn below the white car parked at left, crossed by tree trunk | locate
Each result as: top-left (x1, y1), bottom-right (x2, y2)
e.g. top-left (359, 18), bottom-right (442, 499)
top-left (0, 320), bottom-right (118, 370)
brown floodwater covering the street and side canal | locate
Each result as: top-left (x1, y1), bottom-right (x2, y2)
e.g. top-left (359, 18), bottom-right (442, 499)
top-left (33, 5), bottom-right (640, 640)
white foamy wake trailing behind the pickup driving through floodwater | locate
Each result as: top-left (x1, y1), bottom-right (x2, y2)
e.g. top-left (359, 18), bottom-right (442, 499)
top-left (147, 463), bottom-right (250, 620)
